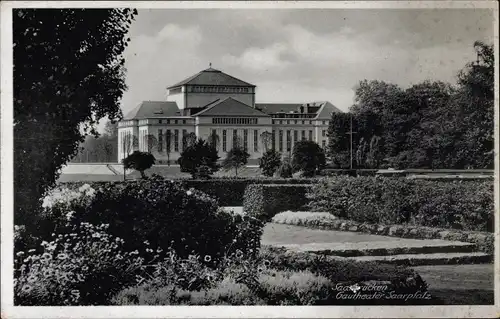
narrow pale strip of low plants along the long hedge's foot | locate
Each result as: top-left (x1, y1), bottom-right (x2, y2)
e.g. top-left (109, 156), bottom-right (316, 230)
top-left (272, 218), bottom-right (495, 254)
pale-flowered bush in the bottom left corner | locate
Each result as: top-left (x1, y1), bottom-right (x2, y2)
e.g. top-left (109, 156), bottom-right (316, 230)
top-left (14, 223), bottom-right (144, 306)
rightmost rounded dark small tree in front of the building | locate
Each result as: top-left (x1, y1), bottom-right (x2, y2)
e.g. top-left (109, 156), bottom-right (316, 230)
top-left (292, 141), bottom-right (326, 176)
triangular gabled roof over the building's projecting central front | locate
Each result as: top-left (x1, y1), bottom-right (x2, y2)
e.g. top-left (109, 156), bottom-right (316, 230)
top-left (194, 97), bottom-right (269, 117)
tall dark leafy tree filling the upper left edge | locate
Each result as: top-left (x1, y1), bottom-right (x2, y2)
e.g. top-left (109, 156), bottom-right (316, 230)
top-left (12, 9), bottom-right (137, 229)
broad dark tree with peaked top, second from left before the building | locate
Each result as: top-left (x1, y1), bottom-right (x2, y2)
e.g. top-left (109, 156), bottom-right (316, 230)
top-left (177, 138), bottom-right (219, 178)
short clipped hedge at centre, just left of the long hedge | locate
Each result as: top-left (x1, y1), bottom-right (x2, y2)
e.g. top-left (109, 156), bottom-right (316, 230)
top-left (243, 184), bottom-right (311, 220)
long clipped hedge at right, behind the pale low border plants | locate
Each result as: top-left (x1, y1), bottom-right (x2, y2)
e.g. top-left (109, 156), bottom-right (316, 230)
top-left (307, 176), bottom-right (494, 232)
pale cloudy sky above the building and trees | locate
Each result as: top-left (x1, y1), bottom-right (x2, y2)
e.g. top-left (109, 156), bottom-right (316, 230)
top-left (115, 9), bottom-right (493, 120)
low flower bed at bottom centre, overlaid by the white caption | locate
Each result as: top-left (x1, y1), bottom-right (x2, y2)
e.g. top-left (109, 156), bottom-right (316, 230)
top-left (113, 247), bottom-right (433, 305)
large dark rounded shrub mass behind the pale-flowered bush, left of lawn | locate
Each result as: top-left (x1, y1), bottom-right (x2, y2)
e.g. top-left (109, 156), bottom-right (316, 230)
top-left (37, 177), bottom-right (262, 258)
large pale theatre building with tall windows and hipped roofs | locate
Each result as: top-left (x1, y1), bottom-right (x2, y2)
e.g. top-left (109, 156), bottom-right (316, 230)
top-left (118, 67), bottom-right (340, 164)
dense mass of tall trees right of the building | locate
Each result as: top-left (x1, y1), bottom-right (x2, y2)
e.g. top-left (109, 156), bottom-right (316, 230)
top-left (328, 42), bottom-right (494, 169)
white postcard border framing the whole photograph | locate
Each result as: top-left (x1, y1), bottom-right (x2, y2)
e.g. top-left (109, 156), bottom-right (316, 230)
top-left (0, 1), bottom-right (500, 318)
